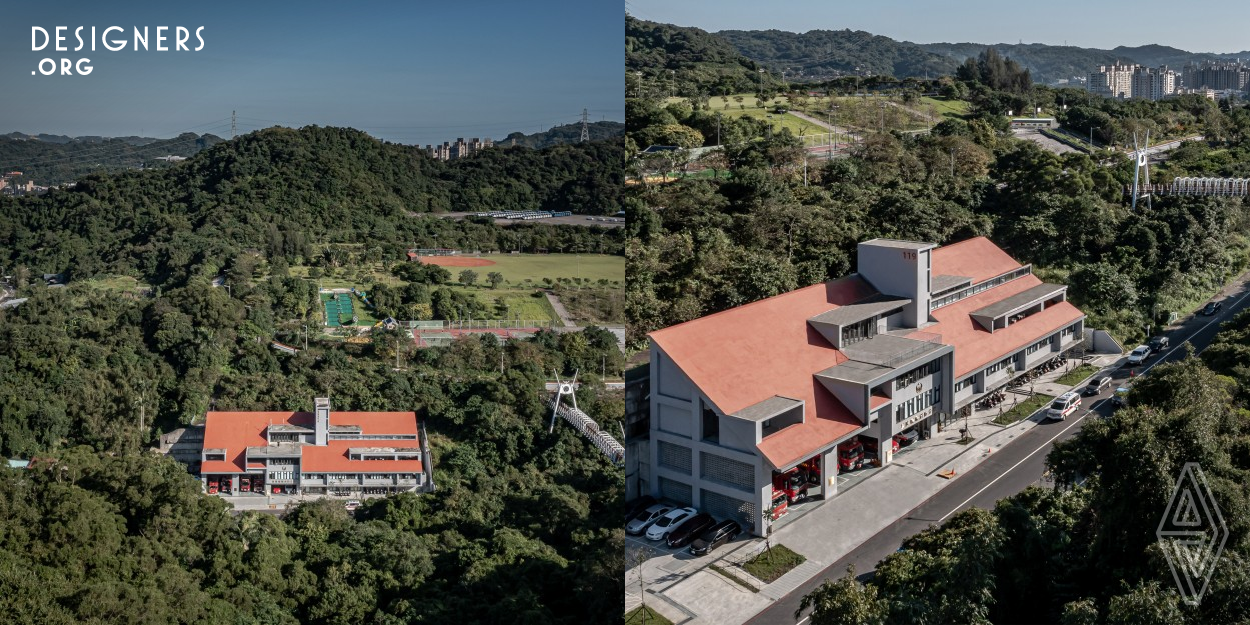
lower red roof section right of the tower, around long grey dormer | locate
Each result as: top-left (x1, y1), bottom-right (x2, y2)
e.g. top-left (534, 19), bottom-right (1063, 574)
top-left (923, 274), bottom-right (1085, 379)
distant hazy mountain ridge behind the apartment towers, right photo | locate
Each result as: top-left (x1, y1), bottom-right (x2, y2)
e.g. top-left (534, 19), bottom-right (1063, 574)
top-left (711, 25), bottom-right (1250, 83)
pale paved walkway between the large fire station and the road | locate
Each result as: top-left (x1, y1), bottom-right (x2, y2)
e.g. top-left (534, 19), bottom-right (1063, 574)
top-left (625, 356), bottom-right (1123, 625)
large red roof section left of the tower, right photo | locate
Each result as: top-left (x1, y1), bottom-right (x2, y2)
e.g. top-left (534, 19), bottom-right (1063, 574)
top-left (650, 275), bottom-right (876, 466)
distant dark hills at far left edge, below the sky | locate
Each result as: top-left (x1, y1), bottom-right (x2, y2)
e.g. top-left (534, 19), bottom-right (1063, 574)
top-left (0, 133), bottom-right (221, 186)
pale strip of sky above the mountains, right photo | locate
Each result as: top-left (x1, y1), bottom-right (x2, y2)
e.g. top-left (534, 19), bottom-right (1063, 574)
top-left (625, 0), bottom-right (1250, 53)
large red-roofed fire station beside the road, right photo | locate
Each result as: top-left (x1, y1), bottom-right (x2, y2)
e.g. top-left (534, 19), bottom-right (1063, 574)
top-left (649, 238), bottom-right (1085, 534)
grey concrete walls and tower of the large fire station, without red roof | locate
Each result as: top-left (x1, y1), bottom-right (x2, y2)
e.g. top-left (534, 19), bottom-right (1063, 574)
top-left (639, 240), bottom-right (1084, 535)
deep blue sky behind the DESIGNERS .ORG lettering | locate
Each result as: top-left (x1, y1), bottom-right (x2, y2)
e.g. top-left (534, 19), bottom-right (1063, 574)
top-left (0, 0), bottom-right (625, 145)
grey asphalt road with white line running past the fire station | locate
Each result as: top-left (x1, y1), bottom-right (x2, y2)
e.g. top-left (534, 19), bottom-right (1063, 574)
top-left (748, 276), bottom-right (1250, 625)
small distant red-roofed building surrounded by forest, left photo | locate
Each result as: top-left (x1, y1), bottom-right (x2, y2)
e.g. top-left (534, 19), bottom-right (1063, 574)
top-left (200, 398), bottom-right (429, 496)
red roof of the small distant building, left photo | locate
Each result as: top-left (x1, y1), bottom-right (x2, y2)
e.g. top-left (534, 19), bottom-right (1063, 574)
top-left (200, 411), bottom-right (421, 474)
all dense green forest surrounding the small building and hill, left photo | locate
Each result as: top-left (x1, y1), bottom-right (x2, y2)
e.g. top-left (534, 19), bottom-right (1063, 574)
top-left (0, 120), bottom-right (624, 625)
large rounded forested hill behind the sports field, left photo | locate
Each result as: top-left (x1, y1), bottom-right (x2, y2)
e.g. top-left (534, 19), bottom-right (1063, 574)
top-left (0, 126), bottom-right (623, 284)
